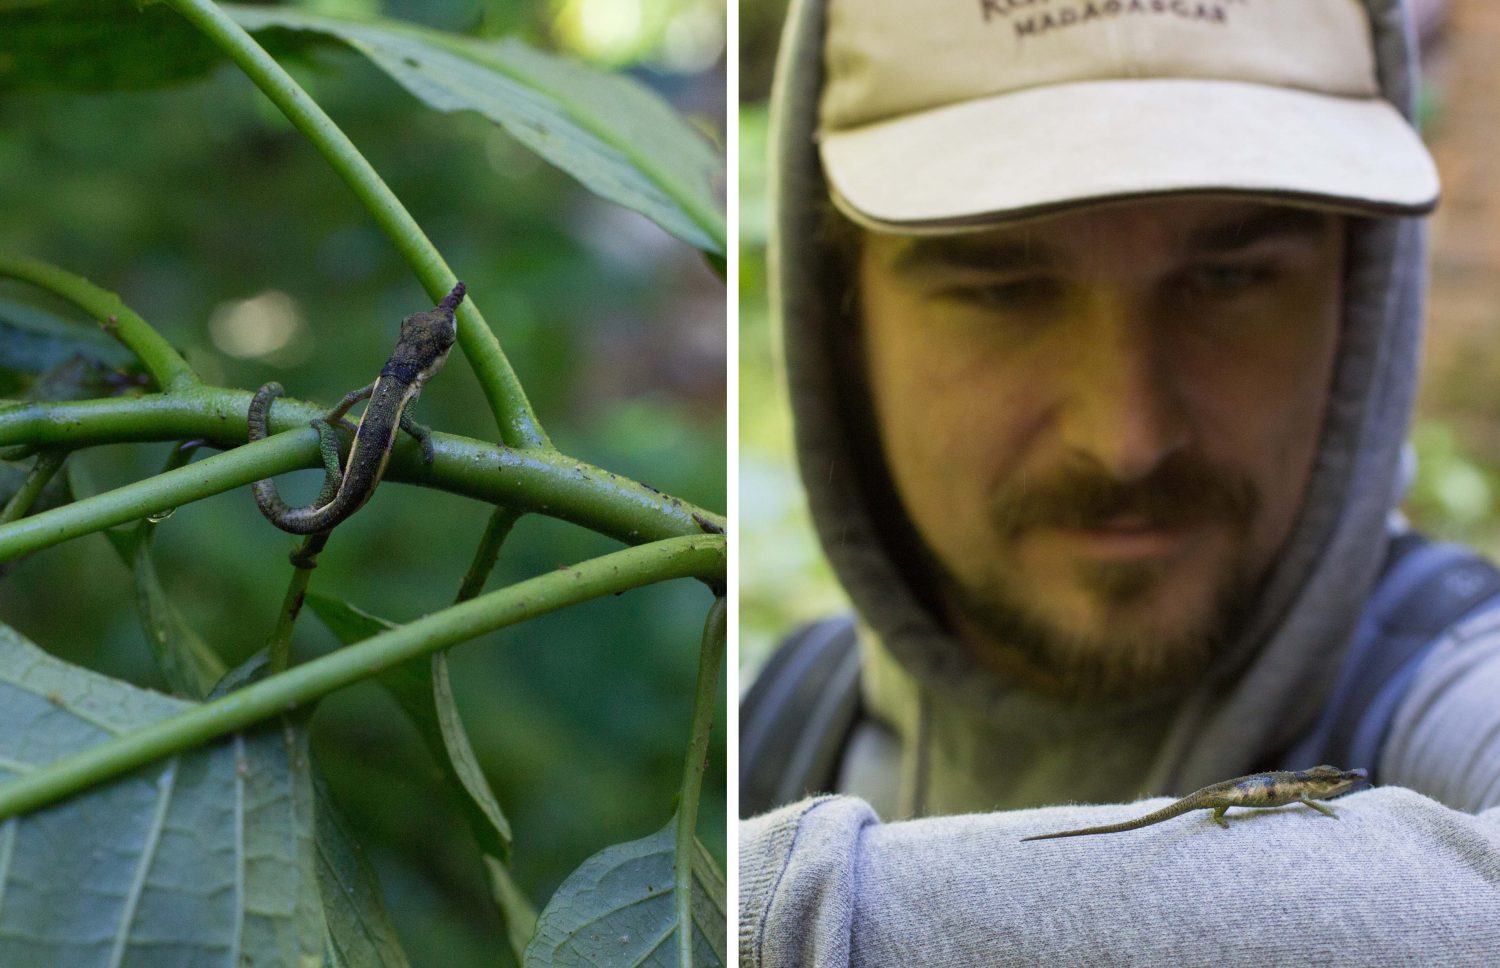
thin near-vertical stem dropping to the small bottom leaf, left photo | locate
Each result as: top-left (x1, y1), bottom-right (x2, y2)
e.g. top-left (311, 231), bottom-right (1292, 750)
top-left (674, 596), bottom-right (728, 968)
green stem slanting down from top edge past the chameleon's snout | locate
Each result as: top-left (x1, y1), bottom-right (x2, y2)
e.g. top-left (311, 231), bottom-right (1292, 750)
top-left (167, 0), bottom-right (551, 449)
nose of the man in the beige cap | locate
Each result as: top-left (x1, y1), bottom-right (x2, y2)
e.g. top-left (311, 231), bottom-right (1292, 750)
top-left (1061, 294), bottom-right (1190, 480)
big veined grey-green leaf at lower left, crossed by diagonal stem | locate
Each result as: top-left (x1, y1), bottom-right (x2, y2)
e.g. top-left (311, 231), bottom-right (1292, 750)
top-left (0, 626), bottom-right (324, 968)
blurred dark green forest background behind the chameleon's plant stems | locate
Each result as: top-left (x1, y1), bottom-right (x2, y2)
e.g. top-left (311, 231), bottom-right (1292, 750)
top-left (0, 0), bottom-right (726, 966)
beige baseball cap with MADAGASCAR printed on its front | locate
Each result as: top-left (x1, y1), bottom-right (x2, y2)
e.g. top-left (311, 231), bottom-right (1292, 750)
top-left (819, 0), bottom-right (1439, 233)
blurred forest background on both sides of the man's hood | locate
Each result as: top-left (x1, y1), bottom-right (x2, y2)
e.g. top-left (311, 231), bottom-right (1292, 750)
top-left (740, 0), bottom-right (1500, 675)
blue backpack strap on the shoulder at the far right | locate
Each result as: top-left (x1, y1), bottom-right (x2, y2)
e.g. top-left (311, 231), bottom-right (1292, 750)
top-left (1284, 531), bottom-right (1500, 779)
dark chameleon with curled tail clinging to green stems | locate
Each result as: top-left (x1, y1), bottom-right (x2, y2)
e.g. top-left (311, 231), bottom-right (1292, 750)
top-left (248, 282), bottom-right (464, 534)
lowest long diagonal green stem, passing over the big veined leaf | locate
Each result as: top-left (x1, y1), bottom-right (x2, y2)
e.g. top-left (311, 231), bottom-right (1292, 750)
top-left (0, 534), bottom-right (726, 819)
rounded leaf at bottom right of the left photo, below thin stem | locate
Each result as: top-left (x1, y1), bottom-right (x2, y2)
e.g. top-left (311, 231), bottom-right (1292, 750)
top-left (525, 819), bottom-right (728, 968)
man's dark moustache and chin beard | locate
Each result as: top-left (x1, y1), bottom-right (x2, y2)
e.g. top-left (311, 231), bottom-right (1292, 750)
top-left (927, 453), bottom-right (1260, 698)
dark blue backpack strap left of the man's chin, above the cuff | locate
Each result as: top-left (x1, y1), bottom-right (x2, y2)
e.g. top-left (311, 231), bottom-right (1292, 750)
top-left (740, 615), bottom-right (861, 816)
